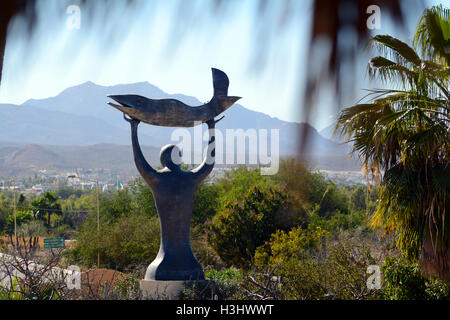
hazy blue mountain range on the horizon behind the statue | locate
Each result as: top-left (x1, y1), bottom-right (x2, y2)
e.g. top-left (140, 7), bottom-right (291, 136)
top-left (0, 82), bottom-right (359, 176)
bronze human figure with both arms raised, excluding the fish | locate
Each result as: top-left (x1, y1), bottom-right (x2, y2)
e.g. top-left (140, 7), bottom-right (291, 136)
top-left (124, 115), bottom-right (217, 280)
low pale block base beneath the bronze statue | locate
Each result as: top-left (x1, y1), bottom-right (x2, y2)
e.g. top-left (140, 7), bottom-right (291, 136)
top-left (139, 280), bottom-right (215, 300)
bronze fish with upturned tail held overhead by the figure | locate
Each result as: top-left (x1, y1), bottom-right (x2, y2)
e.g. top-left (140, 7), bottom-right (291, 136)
top-left (108, 68), bottom-right (241, 127)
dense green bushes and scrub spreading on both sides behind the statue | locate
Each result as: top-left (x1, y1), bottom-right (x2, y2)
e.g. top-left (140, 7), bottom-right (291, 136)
top-left (0, 160), bottom-right (449, 299)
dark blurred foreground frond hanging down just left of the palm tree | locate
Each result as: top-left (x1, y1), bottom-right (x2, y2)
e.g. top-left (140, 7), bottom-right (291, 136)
top-left (299, 0), bottom-right (408, 156)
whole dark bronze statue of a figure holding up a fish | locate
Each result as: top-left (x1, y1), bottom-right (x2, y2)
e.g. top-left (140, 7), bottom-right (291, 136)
top-left (110, 69), bottom-right (241, 280)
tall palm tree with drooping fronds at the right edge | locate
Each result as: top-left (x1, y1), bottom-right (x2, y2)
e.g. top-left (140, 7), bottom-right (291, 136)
top-left (336, 6), bottom-right (450, 278)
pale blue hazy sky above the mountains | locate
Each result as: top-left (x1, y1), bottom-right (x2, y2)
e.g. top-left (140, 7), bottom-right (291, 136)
top-left (0, 0), bottom-right (437, 129)
